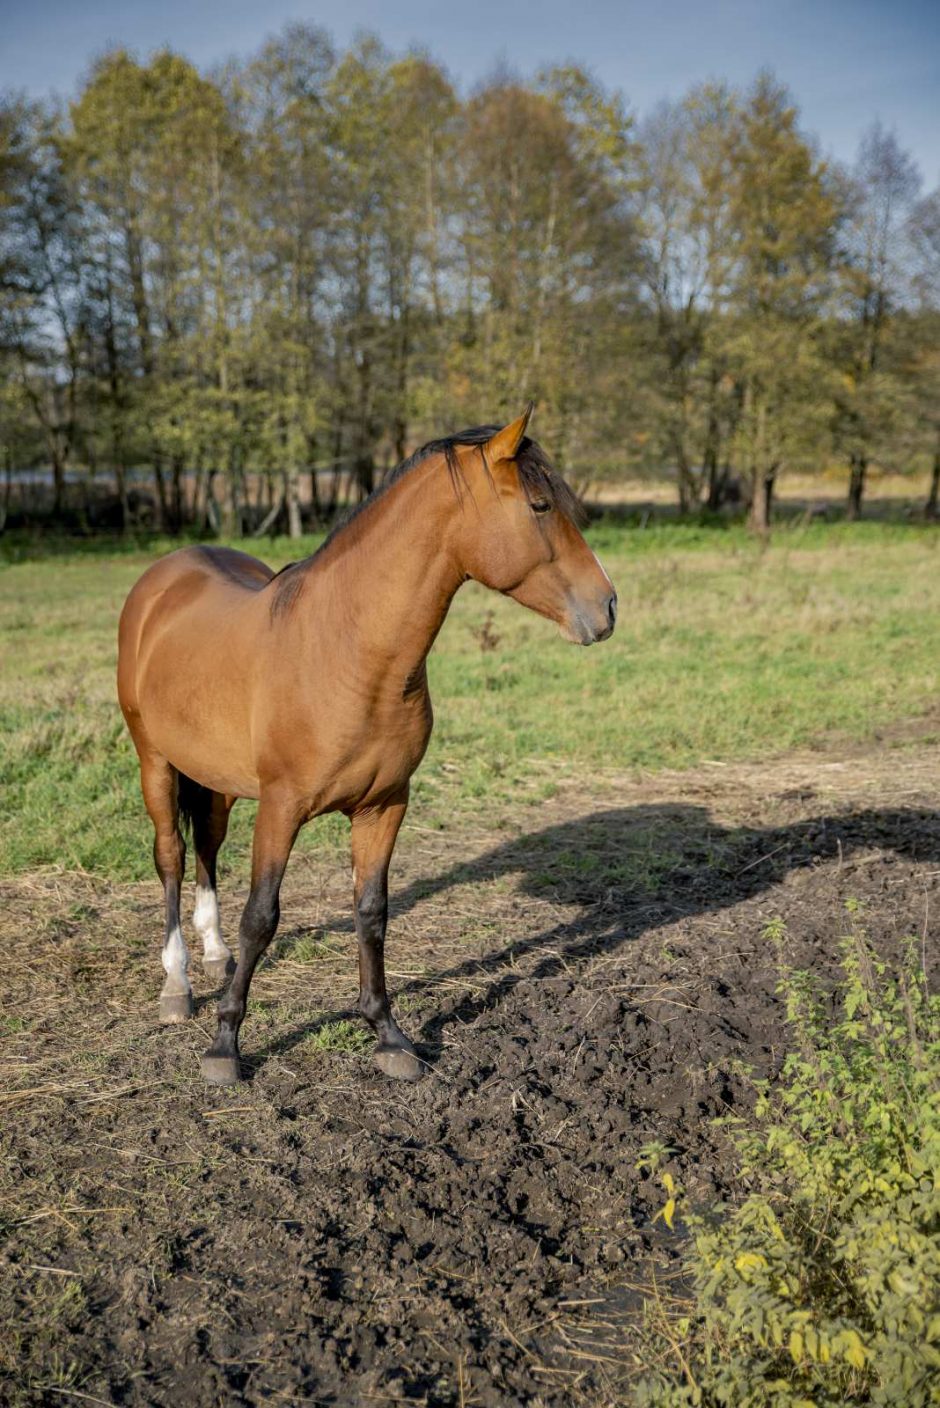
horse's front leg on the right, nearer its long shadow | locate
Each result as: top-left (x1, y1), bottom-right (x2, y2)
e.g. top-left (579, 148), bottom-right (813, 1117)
top-left (352, 788), bottom-right (424, 1080)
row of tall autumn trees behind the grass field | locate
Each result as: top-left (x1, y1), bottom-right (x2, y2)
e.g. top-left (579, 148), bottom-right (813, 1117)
top-left (0, 25), bottom-right (940, 535)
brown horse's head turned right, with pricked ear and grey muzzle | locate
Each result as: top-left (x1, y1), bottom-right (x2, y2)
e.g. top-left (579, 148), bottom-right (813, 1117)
top-left (457, 406), bottom-right (616, 645)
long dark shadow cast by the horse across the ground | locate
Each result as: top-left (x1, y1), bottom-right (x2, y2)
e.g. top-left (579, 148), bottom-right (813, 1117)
top-left (258, 804), bottom-right (940, 1064)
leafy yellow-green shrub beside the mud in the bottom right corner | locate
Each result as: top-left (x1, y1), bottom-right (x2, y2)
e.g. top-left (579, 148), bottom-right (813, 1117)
top-left (637, 907), bottom-right (940, 1408)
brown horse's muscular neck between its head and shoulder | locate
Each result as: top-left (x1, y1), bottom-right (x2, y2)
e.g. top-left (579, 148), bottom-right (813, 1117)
top-left (306, 460), bottom-right (464, 691)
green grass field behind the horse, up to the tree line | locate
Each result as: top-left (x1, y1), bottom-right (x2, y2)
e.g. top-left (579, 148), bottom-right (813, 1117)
top-left (0, 521), bottom-right (940, 879)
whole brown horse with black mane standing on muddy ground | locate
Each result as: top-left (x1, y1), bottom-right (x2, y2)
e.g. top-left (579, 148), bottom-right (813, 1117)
top-left (118, 407), bottom-right (616, 1084)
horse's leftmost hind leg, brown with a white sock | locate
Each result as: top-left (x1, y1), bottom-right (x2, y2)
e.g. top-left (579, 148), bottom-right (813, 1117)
top-left (141, 752), bottom-right (193, 1022)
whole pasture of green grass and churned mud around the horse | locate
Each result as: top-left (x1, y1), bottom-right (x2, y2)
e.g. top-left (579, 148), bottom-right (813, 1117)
top-left (0, 521), bottom-right (940, 1408)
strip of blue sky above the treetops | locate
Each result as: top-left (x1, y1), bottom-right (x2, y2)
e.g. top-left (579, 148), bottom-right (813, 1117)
top-left (0, 0), bottom-right (940, 186)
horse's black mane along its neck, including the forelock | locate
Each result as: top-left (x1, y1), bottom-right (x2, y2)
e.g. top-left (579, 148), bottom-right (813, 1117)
top-left (269, 425), bottom-right (584, 615)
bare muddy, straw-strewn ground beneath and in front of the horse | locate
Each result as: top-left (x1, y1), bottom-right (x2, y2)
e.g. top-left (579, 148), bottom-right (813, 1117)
top-left (0, 743), bottom-right (940, 1408)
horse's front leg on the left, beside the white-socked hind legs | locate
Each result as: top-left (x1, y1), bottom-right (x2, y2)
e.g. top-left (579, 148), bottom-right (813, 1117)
top-left (203, 793), bottom-right (303, 1086)
